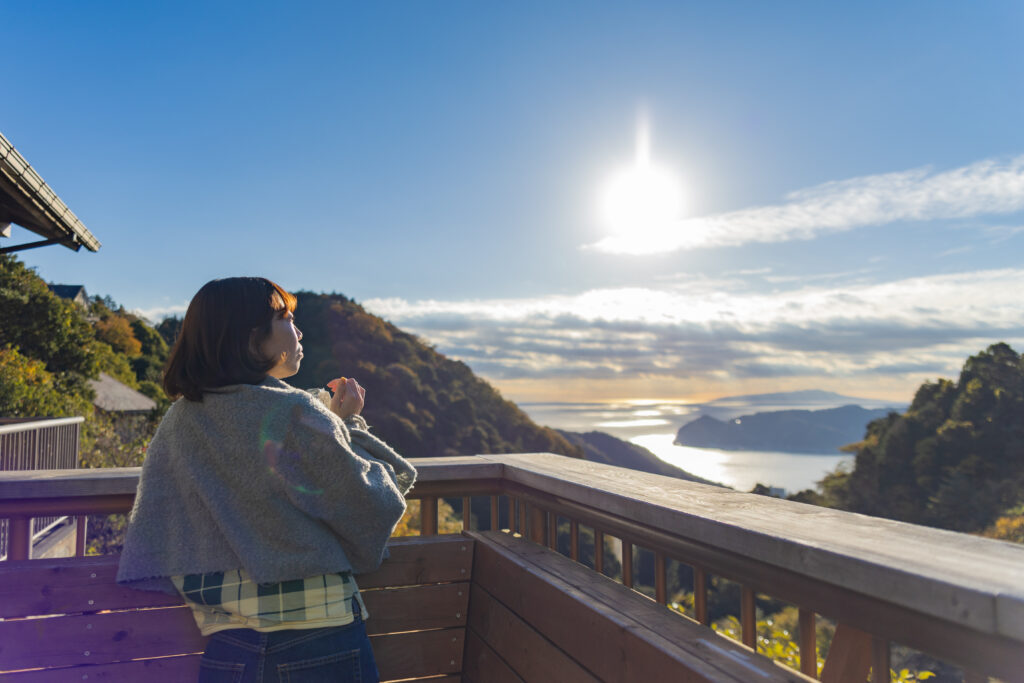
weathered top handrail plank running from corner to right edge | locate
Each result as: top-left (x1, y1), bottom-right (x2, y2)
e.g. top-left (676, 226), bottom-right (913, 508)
top-left (485, 454), bottom-right (1024, 640)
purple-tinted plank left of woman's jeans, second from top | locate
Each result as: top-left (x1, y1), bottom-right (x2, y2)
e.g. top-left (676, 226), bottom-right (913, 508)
top-left (0, 605), bottom-right (206, 671)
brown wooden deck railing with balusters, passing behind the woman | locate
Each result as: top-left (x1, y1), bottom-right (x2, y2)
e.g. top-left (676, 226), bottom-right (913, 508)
top-left (0, 454), bottom-right (1024, 683)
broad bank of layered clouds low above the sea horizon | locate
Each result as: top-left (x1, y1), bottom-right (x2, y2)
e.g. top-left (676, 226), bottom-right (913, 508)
top-left (365, 268), bottom-right (1024, 380)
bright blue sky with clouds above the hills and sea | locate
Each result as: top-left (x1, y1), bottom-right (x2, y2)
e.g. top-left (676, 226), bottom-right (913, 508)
top-left (6, 2), bottom-right (1024, 401)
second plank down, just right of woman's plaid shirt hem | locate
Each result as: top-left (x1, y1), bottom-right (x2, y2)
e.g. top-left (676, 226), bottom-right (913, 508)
top-left (362, 582), bottom-right (469, 635)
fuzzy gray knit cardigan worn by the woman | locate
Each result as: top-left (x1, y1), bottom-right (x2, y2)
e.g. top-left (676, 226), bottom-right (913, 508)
top-left (118, 377), bottom-right (416, 593)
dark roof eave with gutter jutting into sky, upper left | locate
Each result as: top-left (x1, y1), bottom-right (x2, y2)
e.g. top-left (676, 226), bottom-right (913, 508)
top-left (0, 134), bottom-right (99, 251)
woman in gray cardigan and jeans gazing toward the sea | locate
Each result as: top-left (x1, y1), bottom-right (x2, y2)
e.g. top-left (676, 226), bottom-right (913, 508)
top-left (118, 278), bottom-right (416, 681)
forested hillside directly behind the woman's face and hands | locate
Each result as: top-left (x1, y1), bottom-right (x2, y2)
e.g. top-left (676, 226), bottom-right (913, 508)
top-left (288, 292), bottom-right (583, 458)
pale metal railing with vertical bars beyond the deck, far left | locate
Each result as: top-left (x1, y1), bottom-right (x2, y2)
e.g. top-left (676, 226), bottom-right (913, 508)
top-left (0, 417), bottom-right (85, 558)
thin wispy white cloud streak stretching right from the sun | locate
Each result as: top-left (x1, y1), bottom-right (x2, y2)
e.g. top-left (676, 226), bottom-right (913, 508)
top-left (590, 157), bottom-right (1024, 254)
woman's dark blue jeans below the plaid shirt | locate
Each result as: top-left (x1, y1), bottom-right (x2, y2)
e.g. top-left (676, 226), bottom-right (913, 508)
top-left (199, 600), bottom-right (380, 683)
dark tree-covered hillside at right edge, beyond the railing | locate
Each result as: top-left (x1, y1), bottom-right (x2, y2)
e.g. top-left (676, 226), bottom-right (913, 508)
top-left (798, 343), bottom-right (1024, 540)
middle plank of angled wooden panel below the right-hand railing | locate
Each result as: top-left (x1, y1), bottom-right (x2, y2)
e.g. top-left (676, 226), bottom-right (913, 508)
top-left (469, 586), bottom-right (599, 683)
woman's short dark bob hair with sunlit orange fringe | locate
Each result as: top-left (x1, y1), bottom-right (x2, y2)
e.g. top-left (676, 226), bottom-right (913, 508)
top-left (164, 278), bottom-right (295, 400)
